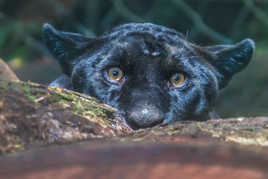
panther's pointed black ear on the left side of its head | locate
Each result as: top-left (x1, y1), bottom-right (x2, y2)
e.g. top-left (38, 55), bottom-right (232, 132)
top-left (43, 24), bottom-right (97, 75)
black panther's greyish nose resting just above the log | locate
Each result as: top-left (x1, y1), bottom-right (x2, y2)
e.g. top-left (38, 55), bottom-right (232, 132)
top-left (126, 105), bottom-right (164, 129)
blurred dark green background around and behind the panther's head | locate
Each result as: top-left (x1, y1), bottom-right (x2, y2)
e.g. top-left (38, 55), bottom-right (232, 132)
top-left (0, 0), bottom-right (268, 117)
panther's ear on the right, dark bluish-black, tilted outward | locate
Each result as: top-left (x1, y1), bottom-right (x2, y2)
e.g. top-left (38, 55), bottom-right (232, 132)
top-left (206, 39), bottom-right (255, 88)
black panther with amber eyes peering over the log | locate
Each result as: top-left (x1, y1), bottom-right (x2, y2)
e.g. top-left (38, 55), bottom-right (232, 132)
top-left (43, 23), bottom-right (255, 129)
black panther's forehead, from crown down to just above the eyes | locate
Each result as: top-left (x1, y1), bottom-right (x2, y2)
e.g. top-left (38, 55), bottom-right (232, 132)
top-left (92, 23), bottom-right (201, 68)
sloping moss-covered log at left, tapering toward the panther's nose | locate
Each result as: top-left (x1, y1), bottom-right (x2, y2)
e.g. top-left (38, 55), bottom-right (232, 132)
top-left (0, 81), bottom-right (132, 154)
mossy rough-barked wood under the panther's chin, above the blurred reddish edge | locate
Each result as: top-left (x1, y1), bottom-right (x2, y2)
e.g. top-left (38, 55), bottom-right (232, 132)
top-left (0, 81), bottom-right (268, 154)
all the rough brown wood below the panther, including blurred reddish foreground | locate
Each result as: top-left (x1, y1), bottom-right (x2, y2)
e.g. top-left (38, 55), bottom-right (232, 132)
top-left (0, 59), bottom-right (268, 179)
